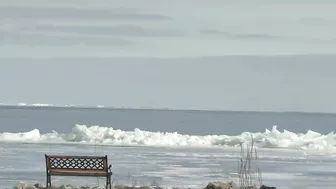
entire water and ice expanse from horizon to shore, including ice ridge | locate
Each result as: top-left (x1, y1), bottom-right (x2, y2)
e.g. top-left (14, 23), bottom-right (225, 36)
top-left (0, 106), bottom-right (336, 189)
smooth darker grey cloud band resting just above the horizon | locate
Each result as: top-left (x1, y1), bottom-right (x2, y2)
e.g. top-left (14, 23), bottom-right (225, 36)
top-left (0, 56), bottom-right (336, 112)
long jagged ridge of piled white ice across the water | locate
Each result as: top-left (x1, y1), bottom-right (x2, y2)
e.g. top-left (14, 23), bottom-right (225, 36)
top-left (0, 125), bottom-right (336, 150)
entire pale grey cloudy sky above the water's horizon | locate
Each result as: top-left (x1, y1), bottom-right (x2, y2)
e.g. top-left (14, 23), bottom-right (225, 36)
top-left (0, 0), bottom-right (336, 112)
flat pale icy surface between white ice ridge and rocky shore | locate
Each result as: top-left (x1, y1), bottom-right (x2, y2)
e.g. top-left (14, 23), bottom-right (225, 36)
top-left (0, 144), bottom-right (336, 189)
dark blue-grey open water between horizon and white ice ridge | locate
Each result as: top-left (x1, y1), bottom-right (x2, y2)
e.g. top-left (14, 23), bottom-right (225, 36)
top-left (0, 106), bottom-right (336, 135)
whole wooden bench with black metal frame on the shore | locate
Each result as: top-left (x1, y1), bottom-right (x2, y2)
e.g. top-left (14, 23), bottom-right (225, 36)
top-left (45, 155), bottom-right (112, 189)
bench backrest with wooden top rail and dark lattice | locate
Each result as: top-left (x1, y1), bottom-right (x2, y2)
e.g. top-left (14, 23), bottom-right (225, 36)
top-left (45, 155), bottom-right (108, 172)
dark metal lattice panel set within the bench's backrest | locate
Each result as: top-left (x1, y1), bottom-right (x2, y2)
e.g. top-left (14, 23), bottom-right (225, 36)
top-left (49, 157), bottom-right (104, 170)
